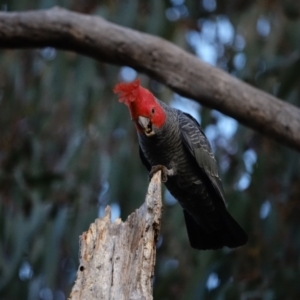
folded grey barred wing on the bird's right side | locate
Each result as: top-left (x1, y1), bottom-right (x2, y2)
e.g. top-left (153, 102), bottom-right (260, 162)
top-left (179, 113), bottom-right (225, 203)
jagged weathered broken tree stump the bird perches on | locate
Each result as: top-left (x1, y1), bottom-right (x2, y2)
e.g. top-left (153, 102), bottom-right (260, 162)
top-left (69, 171), bottom-right (162, 300)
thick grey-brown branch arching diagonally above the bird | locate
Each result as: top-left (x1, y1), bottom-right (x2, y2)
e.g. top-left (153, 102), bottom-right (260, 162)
top-left (0, 8), bottom-right (300, 151)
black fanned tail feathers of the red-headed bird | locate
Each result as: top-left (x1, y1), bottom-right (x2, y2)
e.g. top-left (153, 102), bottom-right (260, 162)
top-left (183, 209), bottom-right (248, 250)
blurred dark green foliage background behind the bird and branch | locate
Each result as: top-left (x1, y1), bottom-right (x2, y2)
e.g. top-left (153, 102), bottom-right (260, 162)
top-left (0, 0), bottom-right (300, 300)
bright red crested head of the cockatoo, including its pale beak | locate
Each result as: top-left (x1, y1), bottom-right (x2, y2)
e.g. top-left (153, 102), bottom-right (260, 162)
top-left (114, 79), bottom-right (166, 136)
